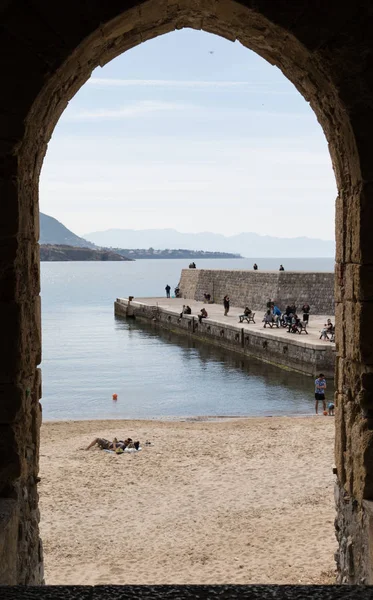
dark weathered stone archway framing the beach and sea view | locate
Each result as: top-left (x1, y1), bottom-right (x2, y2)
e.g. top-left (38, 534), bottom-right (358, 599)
top-left (0, 0), bottom-right (373, 584)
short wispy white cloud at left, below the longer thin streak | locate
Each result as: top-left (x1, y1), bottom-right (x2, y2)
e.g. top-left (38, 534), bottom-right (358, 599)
top-left (67, 101), bottom-right (196, 121)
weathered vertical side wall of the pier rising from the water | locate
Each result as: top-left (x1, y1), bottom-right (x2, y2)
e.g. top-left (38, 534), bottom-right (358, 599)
top-left (114, 298), bottom-right (335, 377)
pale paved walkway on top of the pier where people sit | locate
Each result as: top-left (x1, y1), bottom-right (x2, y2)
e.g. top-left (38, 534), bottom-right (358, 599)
top-left (125, 298), bottom-right (335, 346)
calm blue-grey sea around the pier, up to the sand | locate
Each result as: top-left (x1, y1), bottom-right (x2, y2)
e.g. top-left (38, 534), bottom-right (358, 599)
top-left (41, 258), bottom-right (334, 420)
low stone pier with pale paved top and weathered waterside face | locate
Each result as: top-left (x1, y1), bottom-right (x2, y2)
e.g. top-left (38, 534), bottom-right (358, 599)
top-left (114, 298), bottom-right (335, 377)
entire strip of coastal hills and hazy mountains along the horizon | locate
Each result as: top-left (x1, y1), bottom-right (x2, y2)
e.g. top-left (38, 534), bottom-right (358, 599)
top-left (40, 213), bottom-right (335, 261)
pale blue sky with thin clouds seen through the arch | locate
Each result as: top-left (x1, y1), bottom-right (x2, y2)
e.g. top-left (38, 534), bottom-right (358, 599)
top-left (40, 29), bottom-right (337, 239)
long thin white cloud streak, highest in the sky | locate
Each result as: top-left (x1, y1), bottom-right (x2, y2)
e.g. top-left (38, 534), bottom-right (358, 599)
top-left (87, 77), bottom-right (297, 95)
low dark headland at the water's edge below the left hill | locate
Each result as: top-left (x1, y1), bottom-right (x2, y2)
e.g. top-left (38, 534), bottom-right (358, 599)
top-left (40, 244), bottom-right (132, 262)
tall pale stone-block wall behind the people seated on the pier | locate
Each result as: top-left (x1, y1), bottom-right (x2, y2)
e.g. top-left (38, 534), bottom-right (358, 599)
top-left (180, 269), bottom-right (334, 315)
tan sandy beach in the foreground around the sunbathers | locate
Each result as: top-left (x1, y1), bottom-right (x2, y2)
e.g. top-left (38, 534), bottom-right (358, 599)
top-left (39, 416), bottom-right (336, 584)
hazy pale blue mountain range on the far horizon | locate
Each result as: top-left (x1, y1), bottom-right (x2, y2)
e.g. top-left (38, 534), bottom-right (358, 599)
top-left (84, 229), bottom-right (335, 258)
